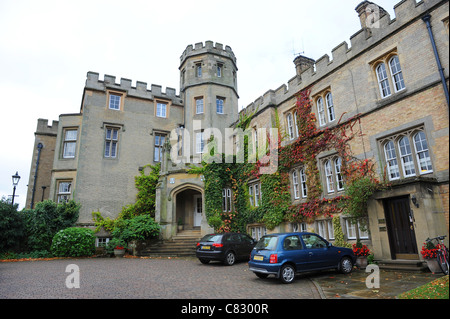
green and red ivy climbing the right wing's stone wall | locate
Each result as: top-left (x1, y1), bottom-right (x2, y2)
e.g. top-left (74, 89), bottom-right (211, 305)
top-left (190, 88), bottom-right (384, 232)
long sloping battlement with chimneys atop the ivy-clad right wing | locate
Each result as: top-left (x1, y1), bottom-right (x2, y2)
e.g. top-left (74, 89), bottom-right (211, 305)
top-left (241, 0), bottom-right (442, 114)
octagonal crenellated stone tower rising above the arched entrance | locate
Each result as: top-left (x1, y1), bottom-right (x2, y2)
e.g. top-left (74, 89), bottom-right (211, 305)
top-left (179, 41), bottom-right (239, 161)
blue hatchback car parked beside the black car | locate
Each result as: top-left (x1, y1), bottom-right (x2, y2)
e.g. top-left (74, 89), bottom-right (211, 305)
top-left (248, 232), bottom-right (356, 284)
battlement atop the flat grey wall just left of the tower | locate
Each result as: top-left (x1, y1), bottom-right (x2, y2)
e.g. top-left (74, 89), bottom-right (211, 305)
top-left (85, 72), bottom-right (183, 105)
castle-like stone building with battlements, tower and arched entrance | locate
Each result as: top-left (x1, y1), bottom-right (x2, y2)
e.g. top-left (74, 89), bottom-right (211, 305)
top-left (27, 0), bottom-right (449, 260)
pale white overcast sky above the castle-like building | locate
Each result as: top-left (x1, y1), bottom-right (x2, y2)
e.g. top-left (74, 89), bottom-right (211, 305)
top-left (0, 0), bottom-right (398, 209)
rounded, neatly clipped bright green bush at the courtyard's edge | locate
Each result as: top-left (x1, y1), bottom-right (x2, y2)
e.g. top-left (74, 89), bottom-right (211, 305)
top-left (51, 227), bottom-right (95, 257)
